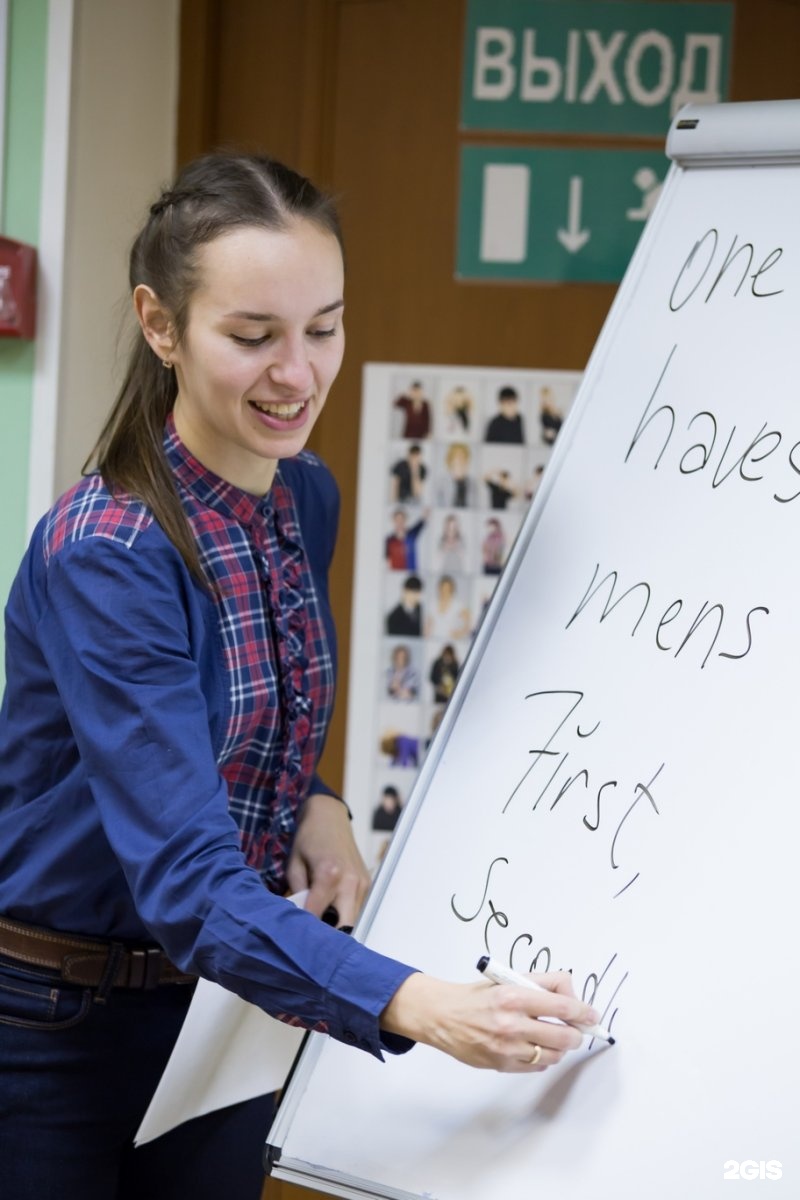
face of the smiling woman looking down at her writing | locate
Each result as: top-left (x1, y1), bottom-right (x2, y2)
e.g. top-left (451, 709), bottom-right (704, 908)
top-left (172, 220), bottom-right (344, 496)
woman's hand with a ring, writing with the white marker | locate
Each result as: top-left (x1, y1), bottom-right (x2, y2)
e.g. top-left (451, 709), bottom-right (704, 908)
top-left (380, 971), bottom-right (599, 1072)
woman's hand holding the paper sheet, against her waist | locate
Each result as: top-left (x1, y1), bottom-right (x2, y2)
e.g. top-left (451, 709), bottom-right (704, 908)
top-left (287, 792), bottom-right (372, 926)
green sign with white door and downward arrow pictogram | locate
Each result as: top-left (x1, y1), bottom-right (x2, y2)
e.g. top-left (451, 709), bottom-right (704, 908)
top-left (456, 145), bottom-right (669, 283)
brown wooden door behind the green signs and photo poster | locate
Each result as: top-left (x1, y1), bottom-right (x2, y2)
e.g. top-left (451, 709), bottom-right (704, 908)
top-left (179, 0), bottom-right (800, 1200)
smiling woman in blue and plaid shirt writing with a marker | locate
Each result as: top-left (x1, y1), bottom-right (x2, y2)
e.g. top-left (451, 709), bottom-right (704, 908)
top-left (0, 155), bottom-right (587, 1200)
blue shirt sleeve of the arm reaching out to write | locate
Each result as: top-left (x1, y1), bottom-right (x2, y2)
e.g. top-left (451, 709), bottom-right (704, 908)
top-left (35, 535), bottom-right (413, 1055)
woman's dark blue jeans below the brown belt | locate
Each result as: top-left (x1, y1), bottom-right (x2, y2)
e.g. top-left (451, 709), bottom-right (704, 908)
top-left (0, 956), bottom-right (273, 1200)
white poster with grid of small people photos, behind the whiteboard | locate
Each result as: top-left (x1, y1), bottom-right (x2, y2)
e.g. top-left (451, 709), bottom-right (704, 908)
top-left (344, 364), bottom-right (581, 869)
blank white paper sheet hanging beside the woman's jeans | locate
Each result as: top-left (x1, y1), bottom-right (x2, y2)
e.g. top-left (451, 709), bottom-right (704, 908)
top-left (134, 893), bottom-right (307, 1146)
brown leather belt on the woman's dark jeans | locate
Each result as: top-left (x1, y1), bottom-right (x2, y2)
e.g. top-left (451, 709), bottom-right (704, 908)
top-left (0, 917), bottom-right (197, 989)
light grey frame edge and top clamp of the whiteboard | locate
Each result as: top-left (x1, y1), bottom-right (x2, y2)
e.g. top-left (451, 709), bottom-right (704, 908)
top-left (265, 101), bottom-right (800, 1200)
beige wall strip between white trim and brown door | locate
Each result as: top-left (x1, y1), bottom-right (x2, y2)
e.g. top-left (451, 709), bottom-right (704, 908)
top-left (55, 0), bottom-right (180, 496)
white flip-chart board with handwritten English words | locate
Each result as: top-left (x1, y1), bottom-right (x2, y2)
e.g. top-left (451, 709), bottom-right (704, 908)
top-left (267, 102), bottom-right (800, 1200)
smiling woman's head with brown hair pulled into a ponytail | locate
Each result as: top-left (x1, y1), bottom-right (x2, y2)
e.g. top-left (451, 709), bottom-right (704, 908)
top-left (90, 155), bottom-right (344, 578)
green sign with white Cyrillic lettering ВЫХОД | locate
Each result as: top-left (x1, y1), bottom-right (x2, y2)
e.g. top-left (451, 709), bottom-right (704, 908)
top-left (462, 0), bottom-right (733, 137)
